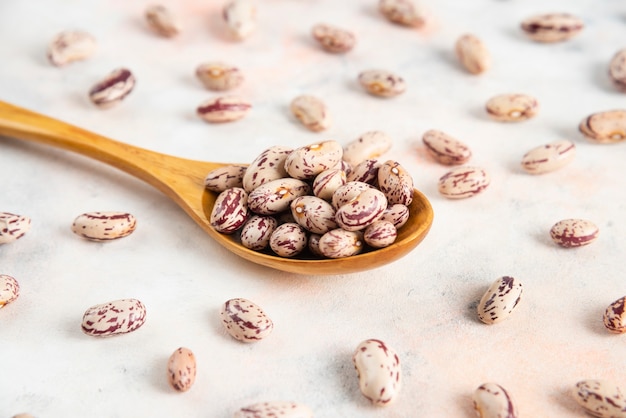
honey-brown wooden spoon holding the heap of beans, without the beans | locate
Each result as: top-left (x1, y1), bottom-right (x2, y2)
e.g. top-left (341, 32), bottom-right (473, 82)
top-left (0, 101), bottom-right (433, 275)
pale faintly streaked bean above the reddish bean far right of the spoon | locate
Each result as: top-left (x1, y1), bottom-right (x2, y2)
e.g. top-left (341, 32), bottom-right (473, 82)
top-left (522, 139), bottom-right (576, 174)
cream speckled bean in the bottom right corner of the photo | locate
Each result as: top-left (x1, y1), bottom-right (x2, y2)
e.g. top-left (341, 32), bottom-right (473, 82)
top-left (573, 379), bottom-right (626, 418)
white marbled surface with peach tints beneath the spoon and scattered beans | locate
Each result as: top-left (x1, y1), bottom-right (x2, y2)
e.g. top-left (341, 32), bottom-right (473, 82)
top-left (0, 0), bottom-right (626, 418)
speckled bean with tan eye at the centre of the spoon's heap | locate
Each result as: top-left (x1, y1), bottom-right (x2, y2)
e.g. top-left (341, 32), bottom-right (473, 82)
top-left (291, 196), bottom-right (337, 234)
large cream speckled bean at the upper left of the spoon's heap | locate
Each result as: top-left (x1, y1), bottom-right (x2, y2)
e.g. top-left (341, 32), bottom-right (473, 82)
top-left (243, 145), bottom-right (293, 192)
